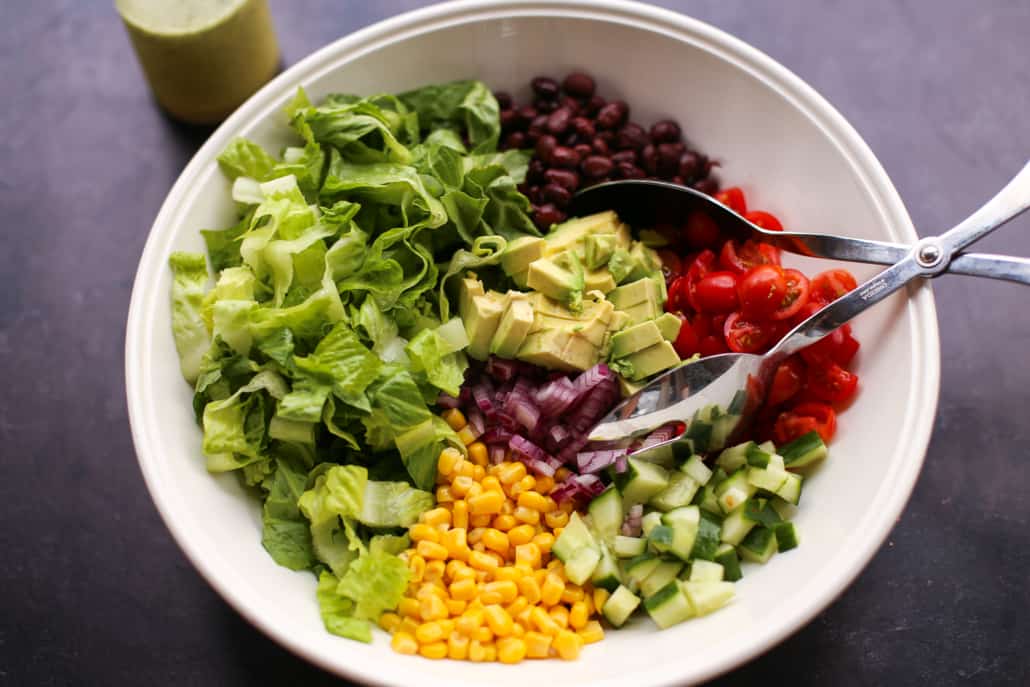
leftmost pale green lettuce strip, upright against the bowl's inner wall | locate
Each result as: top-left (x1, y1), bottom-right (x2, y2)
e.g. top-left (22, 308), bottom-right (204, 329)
top-left (168, 252), bottom-right (211, 384)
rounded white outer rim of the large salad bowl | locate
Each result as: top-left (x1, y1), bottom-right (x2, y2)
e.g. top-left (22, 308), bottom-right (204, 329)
top-left (125, 0), bottom-right (940, 687)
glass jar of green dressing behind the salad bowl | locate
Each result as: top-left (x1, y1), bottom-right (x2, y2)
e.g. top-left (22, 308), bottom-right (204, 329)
top-left (114, 0), bottom-right (279, 124)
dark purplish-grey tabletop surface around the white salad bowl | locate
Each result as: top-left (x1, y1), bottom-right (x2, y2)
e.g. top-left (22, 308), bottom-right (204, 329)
top-left (0, 0), bottom-right (1030, 685)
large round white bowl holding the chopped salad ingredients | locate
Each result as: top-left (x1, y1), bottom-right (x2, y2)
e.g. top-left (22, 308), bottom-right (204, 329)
top-left (126, 0), bottom-right (939, 687)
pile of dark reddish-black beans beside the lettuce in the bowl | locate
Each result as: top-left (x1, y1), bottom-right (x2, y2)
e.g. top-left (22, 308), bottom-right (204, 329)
top-left (494, 72), bottom-right (719, 231)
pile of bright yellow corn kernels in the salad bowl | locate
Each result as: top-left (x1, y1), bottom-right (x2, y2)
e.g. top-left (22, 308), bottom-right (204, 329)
top-left (379, 410), bottom-right (608, 663)
